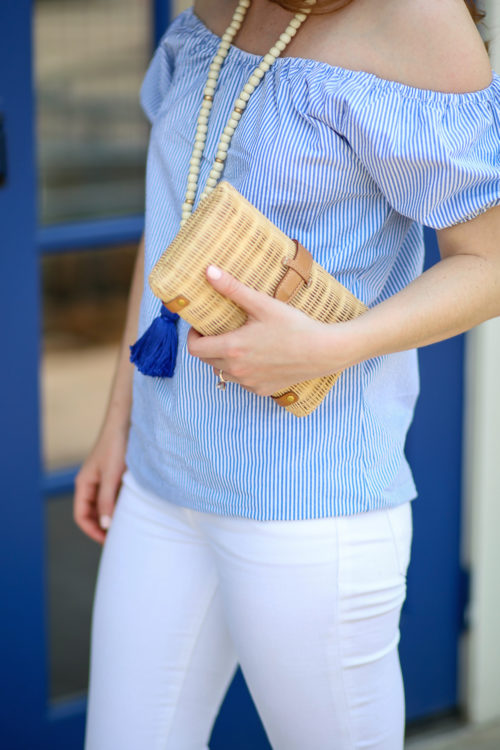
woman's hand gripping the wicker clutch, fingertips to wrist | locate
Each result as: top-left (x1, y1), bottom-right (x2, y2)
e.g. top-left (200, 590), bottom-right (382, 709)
top-left (187, 266), bottom-right (349, 396)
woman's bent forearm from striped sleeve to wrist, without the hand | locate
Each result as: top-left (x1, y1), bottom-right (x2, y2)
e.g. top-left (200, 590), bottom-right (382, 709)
top-left (328, 206), bottom-right (500, 364)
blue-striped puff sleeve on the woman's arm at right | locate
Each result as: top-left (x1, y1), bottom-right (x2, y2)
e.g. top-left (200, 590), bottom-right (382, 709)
top-left (324, 73), bottom-right (500, 229)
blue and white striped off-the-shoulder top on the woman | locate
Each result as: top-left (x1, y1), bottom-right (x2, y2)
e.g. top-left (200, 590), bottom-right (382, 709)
top-left (126, 8), bottom-right (500, 520)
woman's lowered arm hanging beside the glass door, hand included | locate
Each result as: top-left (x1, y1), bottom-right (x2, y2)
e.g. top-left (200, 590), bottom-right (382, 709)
top-left (73, 235), bottom-right (144, 543)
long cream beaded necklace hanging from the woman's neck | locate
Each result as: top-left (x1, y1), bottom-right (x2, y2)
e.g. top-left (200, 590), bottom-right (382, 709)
top-left (180, 0), bottom-right (316, 226)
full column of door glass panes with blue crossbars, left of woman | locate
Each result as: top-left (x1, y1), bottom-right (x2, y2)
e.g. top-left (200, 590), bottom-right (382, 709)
top-left (33, 0), bottom-right (151, 706)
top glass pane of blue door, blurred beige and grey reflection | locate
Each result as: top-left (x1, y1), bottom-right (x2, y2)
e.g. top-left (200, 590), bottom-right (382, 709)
top-left (34, 0), bottom-right (152, 224)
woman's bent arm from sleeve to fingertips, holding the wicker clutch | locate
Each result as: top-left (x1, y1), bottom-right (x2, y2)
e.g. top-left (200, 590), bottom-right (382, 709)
top-left (187, 207), bottom-right (500, 396)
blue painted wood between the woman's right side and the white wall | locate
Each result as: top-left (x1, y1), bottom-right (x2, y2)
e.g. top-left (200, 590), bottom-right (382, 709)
top-left (400, 231), bottom-right (464, 719)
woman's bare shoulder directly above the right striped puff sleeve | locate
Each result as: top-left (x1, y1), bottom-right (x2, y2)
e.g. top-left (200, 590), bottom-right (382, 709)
top-left (372, 0), bottom-right (491, 93)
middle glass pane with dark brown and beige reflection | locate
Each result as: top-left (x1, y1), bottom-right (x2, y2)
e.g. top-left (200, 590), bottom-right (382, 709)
top-left (41, 245), bottom-right (137, 469)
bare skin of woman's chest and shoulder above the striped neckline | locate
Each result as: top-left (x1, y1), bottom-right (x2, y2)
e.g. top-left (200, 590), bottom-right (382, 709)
top-left (194, 0), bottom-right (491, 93)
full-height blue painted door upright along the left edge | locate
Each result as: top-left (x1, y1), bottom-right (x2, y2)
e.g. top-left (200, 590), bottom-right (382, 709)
top-left (0, 0), bottom-right (48, 750)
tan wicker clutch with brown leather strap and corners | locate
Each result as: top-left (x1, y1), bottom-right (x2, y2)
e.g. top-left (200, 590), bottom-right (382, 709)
top-left (149, 180), bottom-right (367, 417)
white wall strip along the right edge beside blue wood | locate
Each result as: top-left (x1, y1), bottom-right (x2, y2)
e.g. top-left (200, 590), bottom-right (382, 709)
top-left (461, 0), bottom-right (500, 722)
